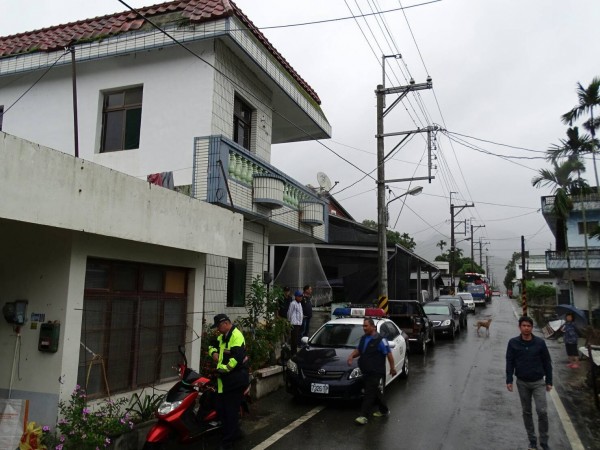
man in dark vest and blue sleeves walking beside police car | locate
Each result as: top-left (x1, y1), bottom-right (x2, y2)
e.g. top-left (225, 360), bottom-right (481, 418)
top-left (348, 318), bottom-right (396, 425)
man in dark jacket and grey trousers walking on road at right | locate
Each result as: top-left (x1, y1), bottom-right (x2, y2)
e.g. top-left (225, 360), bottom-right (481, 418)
top-left (506, 316), bottom-right (552, 450)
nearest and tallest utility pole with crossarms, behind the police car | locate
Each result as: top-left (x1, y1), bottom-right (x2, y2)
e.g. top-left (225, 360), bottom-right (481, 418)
top-left (375, 55), bottom-right (432, 298)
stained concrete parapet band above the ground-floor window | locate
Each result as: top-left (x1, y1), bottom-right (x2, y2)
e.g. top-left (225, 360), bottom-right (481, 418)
top-left (0, 132), bottom-right (242, 258)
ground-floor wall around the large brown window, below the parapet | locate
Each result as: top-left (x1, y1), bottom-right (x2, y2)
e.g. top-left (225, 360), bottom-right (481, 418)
top-left (0, 220), bottom-right (205, 424)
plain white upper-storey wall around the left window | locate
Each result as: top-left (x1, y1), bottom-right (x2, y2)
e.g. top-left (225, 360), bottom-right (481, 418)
top-left (0, 42), bottom-right (214, 185)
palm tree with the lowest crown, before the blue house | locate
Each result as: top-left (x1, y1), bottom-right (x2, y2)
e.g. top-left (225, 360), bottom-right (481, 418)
top-left (531, 157), bottom-right (585, 304)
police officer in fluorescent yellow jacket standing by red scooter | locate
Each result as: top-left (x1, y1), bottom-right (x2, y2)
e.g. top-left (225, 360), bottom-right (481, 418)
top-left (208, 314), bottom-right (249, 449)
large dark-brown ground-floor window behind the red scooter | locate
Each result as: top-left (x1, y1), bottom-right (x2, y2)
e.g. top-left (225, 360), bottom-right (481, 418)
top-left (77, 259), bottom-right (187, 398)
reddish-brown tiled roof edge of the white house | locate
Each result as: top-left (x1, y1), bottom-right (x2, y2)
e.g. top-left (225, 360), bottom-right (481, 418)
top-left (0, 0), bottom-right (321, 104)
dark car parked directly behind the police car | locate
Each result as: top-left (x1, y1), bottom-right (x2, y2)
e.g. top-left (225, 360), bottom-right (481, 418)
top-left (388, 300), bottom-right (435, 353)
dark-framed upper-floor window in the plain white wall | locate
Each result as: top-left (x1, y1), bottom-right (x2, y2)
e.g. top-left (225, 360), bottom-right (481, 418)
top-left (100, 86), bottom-right (143, 153)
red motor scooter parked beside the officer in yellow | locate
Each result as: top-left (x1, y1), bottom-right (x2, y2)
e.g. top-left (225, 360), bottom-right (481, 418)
top-left (143, 345), bottom-right (250, 450)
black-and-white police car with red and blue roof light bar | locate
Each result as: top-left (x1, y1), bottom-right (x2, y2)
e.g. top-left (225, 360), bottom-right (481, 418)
top-left (285, 308), bottom-right (408, 399)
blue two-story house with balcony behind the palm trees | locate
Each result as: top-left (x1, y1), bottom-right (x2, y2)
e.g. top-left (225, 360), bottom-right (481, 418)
top-left (542, 193), bottom-right (600, 315)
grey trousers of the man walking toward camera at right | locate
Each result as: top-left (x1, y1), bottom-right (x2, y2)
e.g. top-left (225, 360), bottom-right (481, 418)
top-left (517, 379), bottom-right (548, 447)
